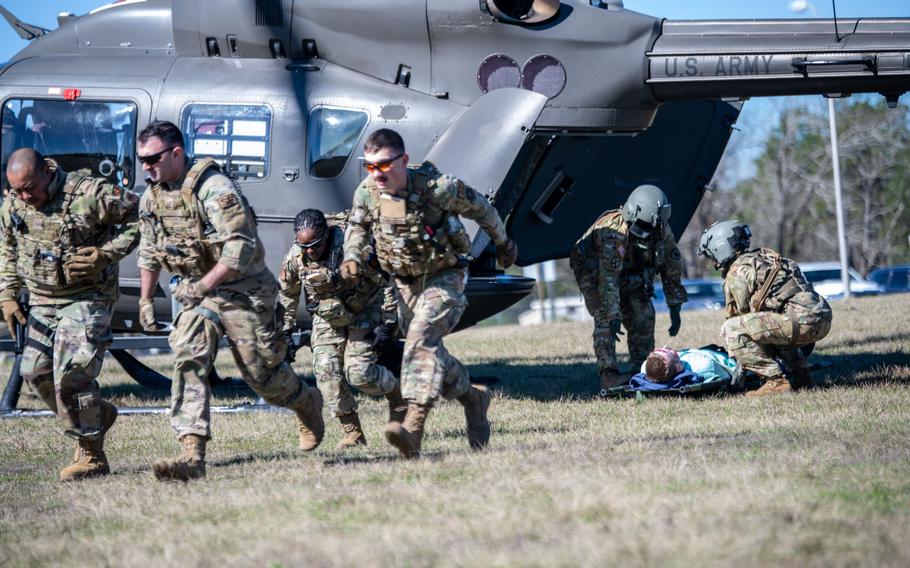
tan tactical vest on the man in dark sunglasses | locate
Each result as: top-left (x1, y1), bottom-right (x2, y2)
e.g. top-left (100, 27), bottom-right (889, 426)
top-left (141, 158), bottom-right (228, 278)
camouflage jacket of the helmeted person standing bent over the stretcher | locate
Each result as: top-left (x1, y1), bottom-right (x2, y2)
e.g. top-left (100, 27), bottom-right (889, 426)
top-left (569, 209), bottom-right (688, 320)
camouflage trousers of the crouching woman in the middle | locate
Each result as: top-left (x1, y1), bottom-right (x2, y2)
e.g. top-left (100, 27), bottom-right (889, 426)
top-left (310, 297), bottom-right (398, 417)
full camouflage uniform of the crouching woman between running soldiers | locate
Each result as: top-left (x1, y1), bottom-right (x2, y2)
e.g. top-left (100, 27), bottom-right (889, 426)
top-left (278, 223), bottom-right (398, 417)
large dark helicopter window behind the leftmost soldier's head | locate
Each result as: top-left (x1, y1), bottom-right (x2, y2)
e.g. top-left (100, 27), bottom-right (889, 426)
top-left (0, 99), bottom-right (136, 187)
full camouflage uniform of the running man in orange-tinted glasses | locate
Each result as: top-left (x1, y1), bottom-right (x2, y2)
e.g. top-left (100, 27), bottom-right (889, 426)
top-left (344, 162), bottom-right (509, 405)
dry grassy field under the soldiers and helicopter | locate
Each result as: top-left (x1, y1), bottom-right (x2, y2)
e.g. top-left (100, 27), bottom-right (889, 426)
top-left (0, 294), bottom-right (910, 566)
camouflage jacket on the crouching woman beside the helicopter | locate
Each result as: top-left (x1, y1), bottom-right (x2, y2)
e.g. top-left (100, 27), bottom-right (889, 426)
top-left (278, 227), bottom-right (397, 331)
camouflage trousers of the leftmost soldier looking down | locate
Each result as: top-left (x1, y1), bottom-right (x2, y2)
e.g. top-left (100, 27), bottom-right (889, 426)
top-left (20, 299), bottom-right (113, 439)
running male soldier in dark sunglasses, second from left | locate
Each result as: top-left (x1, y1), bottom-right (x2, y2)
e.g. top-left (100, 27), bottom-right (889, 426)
top-left (138, 122), bottom-right (325, 481)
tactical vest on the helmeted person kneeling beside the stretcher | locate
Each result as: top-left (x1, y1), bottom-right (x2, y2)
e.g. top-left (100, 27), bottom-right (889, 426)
top-left (747, 248), bottom-right (818, 312)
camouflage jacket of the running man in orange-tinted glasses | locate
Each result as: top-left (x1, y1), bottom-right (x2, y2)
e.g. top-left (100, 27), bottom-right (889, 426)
top-left (344, 162), bottom-right (508, 277)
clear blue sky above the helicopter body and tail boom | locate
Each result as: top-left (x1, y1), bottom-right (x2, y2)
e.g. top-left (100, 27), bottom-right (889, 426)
top-left (0, 0), bottom-right (910, 61)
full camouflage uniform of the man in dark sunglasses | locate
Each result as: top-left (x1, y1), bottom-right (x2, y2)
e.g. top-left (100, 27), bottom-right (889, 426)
top-left (139, 160), bottom-right (307, 439)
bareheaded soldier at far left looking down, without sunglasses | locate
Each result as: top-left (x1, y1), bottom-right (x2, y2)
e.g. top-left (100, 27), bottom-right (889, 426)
top-left (0, 149), bottom-right (139, 481)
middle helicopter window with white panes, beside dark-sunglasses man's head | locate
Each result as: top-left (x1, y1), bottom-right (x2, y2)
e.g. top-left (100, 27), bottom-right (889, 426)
top-left (181, 104), bottom-right (272, 180)
